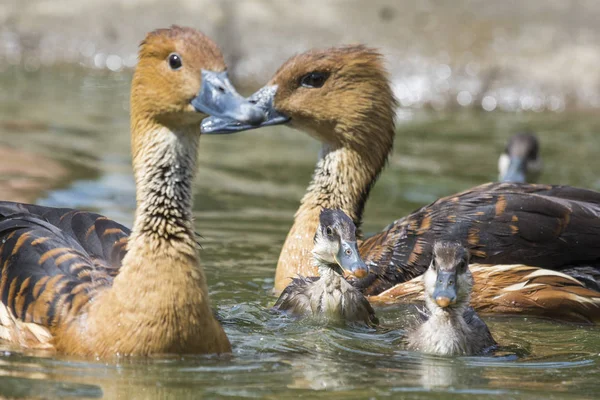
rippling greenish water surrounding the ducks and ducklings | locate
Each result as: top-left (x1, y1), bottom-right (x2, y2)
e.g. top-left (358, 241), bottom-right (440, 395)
top-left (0, 69), bottom-right (600, 399)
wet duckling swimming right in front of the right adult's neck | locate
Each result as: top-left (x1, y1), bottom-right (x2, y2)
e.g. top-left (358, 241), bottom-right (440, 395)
top-left (273, 208), bottom-right (378, 326)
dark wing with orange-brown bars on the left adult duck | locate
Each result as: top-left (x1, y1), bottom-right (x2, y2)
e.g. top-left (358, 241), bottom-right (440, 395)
top-left (0, 202), bottom-right (129, 334)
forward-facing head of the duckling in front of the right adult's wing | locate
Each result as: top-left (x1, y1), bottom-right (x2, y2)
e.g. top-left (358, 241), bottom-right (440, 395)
top-left (423, 242), bottom-right (473, 311)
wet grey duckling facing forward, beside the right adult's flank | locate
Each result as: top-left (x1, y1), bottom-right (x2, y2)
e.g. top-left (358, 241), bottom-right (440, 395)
top-left (407, 242), bottom-right (496, 356)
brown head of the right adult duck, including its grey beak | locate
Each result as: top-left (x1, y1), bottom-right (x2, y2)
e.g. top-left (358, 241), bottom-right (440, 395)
top-left (202, 45), bottom-right (396, 152)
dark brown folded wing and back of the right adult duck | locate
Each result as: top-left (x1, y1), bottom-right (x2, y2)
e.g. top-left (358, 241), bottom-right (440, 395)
top-left (354, 183), bottom-right (600, 295)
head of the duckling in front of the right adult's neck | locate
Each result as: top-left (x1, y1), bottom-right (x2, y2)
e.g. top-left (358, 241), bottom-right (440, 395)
top-left (312, 208), bottom-right (369, 278)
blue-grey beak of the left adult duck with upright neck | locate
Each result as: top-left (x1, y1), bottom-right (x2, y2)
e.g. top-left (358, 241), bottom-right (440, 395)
top-left (191, 70), bottom-right (265, 126)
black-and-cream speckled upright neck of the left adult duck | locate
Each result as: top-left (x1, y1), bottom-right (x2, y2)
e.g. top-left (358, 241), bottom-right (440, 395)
top-left (129, 124), bottom-right (200, 253)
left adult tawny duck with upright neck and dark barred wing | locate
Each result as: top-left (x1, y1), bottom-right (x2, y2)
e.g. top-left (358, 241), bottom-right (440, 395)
top-left (0, 26), bottom-right (264, 358)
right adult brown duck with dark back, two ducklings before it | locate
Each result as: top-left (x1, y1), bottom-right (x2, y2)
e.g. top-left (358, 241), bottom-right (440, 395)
top-left (202, 45), bottom-right (600, 319)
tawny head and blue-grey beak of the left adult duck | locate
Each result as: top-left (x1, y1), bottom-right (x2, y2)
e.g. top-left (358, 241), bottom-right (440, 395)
top-left (131, 26), bottom-right (264, 128)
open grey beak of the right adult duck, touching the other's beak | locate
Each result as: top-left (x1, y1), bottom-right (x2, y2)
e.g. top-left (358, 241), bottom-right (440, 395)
top-left (201, 85), bottom-right (290, 134)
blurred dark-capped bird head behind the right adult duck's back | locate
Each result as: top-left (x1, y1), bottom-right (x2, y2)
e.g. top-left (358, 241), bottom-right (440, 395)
top-left (498, 132), bottom-right (542, 183)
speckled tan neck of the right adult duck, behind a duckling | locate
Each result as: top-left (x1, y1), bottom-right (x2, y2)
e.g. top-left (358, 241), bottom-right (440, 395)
top-left (275, 126), bottom-right (394, 292)
